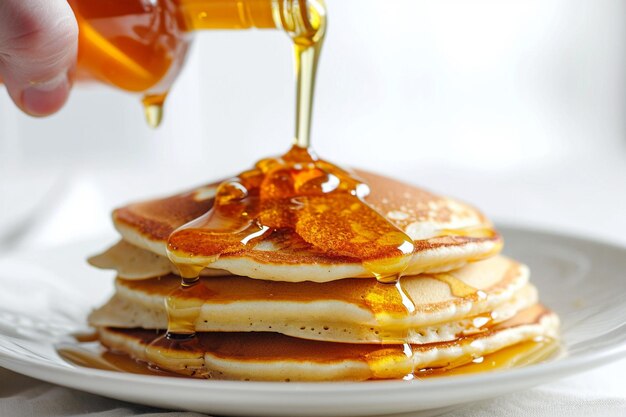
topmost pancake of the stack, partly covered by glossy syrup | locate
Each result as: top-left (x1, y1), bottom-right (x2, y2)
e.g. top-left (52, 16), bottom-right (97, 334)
top-left (113, 171), bottom-right (502, 282)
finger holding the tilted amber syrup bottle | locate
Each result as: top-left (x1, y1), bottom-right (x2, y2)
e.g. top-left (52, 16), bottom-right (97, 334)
top-left (0, 0), bottom-right (78, 116)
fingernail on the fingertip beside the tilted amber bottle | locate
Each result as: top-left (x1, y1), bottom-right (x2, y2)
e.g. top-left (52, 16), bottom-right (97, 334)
top-left (22, 74), bottom-right (70, 116)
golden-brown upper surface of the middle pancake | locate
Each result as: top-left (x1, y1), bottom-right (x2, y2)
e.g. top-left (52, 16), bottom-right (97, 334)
top-left (112, 257), bottom-right (527, 315)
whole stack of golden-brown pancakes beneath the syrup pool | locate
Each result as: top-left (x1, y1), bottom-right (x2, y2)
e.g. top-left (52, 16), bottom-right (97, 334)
top-left (89, 172), bottom-right (558, 381)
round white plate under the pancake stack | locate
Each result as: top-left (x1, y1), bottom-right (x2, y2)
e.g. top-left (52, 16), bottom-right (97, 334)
top-left (0, 224), bottom-right (626, 416)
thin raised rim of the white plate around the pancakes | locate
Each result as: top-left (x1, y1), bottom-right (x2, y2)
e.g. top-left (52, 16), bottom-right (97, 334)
top-left (0, 221), bottom-right (626, 395)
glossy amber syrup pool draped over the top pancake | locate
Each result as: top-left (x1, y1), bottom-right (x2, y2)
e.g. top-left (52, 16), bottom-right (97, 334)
top-left (168, 146), bottom-right (414, 282)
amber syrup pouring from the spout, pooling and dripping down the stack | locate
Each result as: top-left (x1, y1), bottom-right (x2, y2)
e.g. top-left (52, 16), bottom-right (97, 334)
top-left (140, 0), bottom-right (424, 374)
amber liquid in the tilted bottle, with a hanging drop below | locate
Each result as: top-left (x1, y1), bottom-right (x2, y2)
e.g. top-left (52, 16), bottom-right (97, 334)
top-left (52, 0), bottom-right (281, 127)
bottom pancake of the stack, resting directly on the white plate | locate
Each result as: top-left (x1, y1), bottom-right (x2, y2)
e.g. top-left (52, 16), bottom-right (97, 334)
top-left (99, 305), bottom-right (558, 381)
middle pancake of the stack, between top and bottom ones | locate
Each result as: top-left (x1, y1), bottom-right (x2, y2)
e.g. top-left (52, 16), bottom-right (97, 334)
top-left (89, 256), bottom-right (537, 343)
